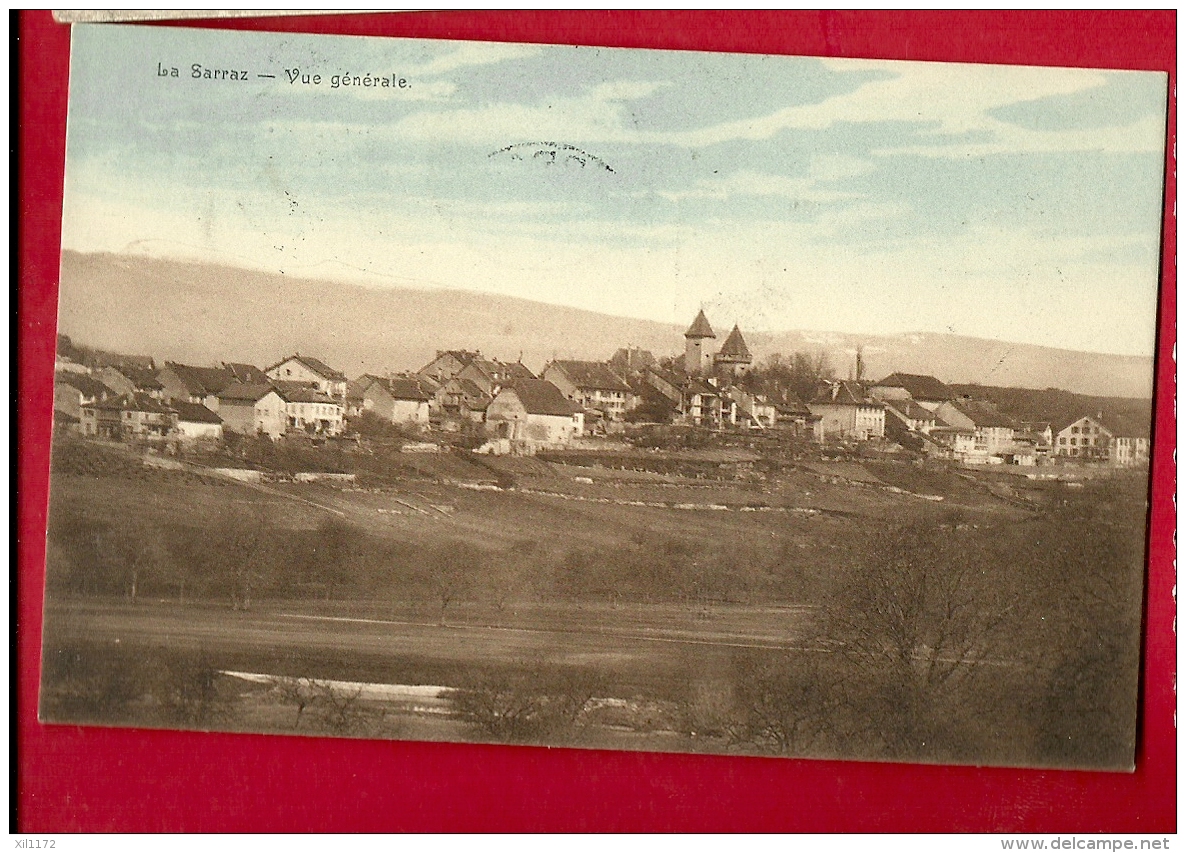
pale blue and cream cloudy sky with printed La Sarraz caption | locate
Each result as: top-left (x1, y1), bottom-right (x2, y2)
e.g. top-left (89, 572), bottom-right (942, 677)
top-left (63, 25), bottom-right (1166, 356)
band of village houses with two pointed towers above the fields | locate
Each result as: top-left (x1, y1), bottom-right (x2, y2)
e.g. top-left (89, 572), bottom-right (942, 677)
top-left (55, 311), bottom-right (1149, 469)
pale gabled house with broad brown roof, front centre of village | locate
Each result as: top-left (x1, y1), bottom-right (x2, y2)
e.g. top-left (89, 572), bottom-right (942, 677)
top-left (486, 380), bottom-right (585, 453)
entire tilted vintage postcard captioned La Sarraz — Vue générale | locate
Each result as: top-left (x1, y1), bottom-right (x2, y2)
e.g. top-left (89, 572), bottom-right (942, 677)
top-left (39, 25), bottom-right (1167, 770)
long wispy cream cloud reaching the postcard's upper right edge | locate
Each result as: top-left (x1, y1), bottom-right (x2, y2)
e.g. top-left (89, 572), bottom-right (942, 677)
top-left (384, 61), bottom-right (1165, 157)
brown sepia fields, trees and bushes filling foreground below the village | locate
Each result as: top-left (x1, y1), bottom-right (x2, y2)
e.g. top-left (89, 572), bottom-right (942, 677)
top-left (42, 441), bottom-right (1143, 766)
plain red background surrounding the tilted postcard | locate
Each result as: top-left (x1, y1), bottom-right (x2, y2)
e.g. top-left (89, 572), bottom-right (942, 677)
top-left (14, 11), bottom-right (1177, 833)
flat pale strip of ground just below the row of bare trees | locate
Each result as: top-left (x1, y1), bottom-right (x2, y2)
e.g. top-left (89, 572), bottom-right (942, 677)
top-left (45, 601), bottom-right (809, 688)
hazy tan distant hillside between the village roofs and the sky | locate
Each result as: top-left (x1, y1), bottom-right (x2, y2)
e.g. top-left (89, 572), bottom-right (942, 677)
top-left (58, 252), bottom-right (1153, 397)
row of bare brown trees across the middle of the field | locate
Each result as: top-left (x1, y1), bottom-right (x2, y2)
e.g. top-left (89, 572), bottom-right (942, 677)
top-left (47, 508), bottom-right (797, 619)
